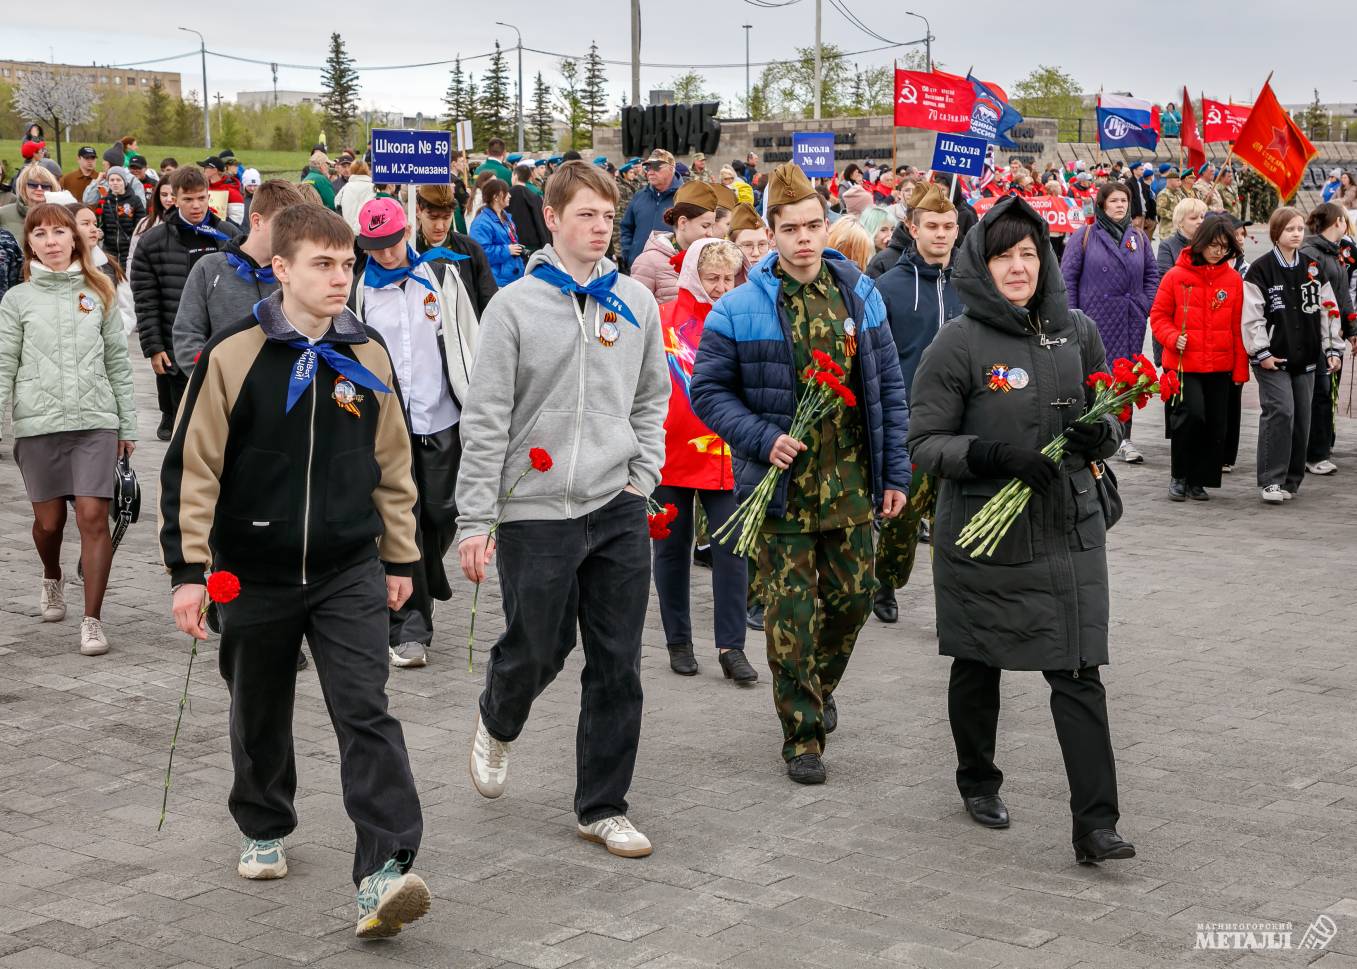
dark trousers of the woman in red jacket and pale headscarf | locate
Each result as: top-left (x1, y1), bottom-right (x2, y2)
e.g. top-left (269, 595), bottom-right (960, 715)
top-left (654, 485), bottom-right (749, 649)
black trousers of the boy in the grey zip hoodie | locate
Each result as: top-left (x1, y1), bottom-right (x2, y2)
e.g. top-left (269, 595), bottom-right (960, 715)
top-left (480, 491), bottom-right (650, 824)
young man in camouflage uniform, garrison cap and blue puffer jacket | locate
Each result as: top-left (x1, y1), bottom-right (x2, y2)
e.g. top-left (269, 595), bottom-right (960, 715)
top-left (692, 164), bottom-right (911, 784)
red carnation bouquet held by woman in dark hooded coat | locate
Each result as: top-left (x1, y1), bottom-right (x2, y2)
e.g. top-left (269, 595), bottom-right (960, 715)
top-left (957, 353), bottom-right (1179, 558)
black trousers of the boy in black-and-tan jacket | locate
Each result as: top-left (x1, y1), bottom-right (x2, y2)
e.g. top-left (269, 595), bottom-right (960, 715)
top-left (217, 558), bottom-right (423, 885)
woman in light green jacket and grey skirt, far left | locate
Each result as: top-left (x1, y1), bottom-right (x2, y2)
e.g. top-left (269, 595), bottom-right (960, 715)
top-left (0, 204), bottom-right (137, 656)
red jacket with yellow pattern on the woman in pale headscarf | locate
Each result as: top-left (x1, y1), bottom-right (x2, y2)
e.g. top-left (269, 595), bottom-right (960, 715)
top-left (660, 283), bottom-right (735, 491)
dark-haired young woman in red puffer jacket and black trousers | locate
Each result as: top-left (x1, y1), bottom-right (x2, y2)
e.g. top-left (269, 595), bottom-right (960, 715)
top-left (1149, 213), bottom-right (1248, 501)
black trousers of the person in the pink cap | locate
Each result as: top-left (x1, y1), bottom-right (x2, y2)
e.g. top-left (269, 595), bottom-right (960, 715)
top-left (388, 425), bottom-right (461, 646)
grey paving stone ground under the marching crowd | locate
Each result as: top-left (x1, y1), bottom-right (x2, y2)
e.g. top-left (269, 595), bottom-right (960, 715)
top-left (0, 333), bottom-right (1357, 969)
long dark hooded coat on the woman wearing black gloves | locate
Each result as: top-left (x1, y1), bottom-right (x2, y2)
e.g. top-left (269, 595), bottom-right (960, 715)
top-left (909, 197), bottom-right (1120, 669)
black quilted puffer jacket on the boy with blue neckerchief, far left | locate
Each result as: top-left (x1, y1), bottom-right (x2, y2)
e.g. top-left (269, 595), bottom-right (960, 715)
top-left (132, 209), bottom-right (240, 360)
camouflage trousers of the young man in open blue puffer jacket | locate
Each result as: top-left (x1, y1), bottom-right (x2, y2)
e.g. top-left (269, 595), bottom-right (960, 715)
top-left (759, 524), bottom-right (877, 760)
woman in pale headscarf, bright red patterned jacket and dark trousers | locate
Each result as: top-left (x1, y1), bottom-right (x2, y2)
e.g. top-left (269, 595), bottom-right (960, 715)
top-left (653, 239), bottom-right (759, 687)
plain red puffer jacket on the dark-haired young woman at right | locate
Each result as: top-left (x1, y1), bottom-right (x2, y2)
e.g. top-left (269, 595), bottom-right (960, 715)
top-left (1149, 250), bottom-right (1248, 384)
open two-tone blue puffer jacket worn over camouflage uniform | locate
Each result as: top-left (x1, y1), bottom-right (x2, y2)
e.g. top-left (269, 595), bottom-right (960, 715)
top-left (692, 250), bottom-right (911, 516)
